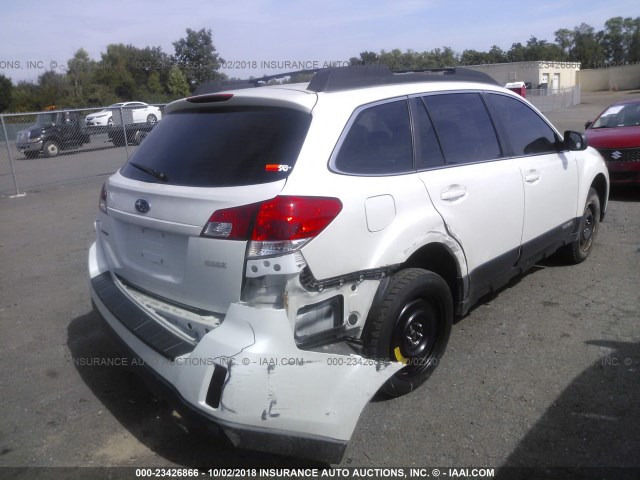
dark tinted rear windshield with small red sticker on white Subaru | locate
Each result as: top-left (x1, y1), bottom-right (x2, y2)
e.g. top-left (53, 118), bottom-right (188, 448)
top-left (121, 107), bottom-right (311, 187)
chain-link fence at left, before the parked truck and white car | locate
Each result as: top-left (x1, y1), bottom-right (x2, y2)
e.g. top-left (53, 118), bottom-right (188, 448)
top-left (0, 102), bottom-right (164, 195)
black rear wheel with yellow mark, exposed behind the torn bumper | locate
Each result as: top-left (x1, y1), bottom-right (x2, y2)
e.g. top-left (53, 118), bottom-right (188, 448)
top-left (363, 268), bottom-right (453, 397)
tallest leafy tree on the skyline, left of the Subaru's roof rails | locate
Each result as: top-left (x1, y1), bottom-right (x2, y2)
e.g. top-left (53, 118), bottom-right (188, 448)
top-left (173, 28), bottom-right (227, 91)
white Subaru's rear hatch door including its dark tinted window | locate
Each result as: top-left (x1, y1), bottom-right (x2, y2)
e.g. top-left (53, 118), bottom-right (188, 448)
top-left (101, 101), bottom-right (311, 313)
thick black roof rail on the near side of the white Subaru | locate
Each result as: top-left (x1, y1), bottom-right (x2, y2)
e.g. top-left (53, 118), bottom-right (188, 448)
top-left (308, 65), bottom-right (499, 92)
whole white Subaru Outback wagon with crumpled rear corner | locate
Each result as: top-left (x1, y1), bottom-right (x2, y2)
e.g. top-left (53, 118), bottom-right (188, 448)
top-left (89, 67), bottom-right (609, 462)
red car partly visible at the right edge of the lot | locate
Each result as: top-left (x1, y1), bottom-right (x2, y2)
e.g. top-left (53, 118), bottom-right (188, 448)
top-left (584, 99), bottom-right (640, 184)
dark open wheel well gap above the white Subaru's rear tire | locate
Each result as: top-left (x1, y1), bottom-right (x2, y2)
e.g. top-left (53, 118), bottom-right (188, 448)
top-left (403, 243), bottom-right (463, 310)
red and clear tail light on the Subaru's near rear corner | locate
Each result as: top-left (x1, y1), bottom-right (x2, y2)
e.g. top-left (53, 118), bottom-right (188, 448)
top-left (202, 196), bottom-right (342, 257)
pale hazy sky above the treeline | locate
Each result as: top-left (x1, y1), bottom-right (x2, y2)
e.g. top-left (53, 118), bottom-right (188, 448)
top-left (0, 0), bottom-right (640, 82)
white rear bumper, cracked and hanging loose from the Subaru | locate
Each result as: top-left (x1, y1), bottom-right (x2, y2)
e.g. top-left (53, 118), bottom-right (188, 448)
top-left (89, 245), bottom-right (401, 463)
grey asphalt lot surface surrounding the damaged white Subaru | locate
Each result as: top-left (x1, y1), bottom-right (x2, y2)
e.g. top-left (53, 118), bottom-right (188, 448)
top-left (0, 92), bottom-right (640, 478)
